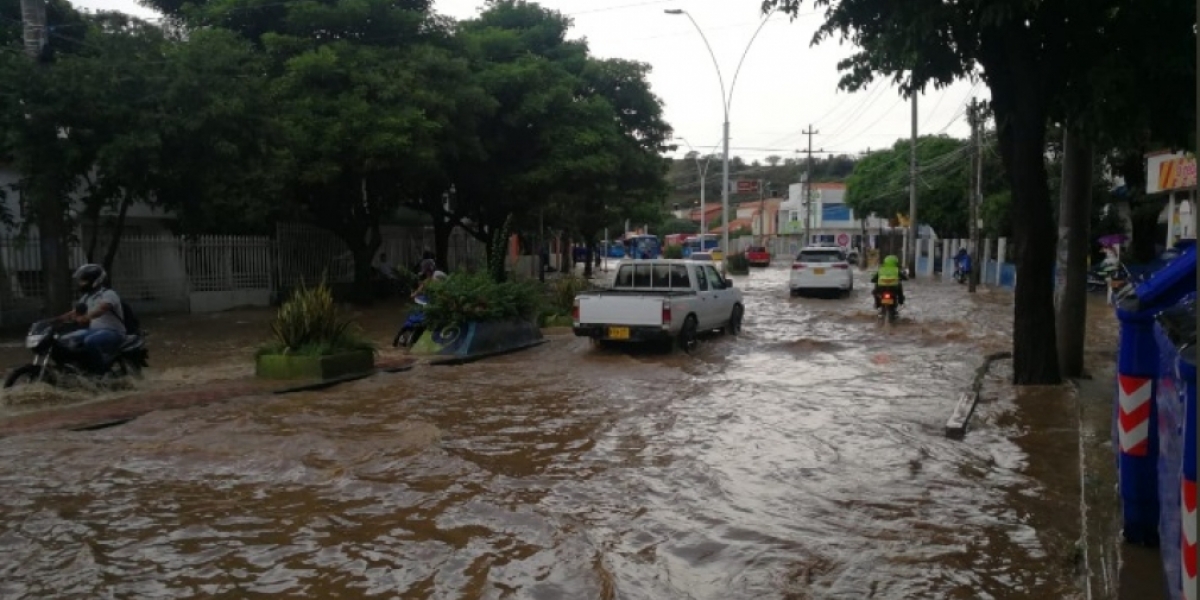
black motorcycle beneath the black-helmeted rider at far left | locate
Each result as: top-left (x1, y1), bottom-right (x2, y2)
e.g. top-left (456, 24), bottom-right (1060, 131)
top-left (4, 319), bottom-right (150, 388)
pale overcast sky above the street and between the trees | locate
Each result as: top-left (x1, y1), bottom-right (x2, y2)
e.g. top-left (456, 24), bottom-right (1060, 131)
top-left (74, 0), bottom-right (988, 160)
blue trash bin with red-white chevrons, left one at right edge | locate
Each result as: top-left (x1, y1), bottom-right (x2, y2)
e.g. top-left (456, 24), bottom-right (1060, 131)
top-left (1112, 245), bottom-right (1196, 546)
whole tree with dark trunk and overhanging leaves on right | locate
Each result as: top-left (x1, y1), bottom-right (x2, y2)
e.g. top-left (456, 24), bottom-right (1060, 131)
top-left (763, 0), bottom-right (1195, 384)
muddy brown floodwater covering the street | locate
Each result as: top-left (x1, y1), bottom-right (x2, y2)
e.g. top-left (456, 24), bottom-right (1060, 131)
top-left (0, 268), bottom-right (1079, 600)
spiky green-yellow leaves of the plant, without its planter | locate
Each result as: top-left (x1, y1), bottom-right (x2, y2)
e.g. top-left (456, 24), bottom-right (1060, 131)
top-left (259, 281), bottom-right (374, 355)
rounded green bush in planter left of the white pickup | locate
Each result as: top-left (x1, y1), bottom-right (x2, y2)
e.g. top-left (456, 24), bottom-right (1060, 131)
top-left (425, 274), bottom-right (542, 328)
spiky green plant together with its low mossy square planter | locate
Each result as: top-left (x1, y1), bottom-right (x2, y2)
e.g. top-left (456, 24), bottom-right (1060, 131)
top-left (256, 282), bottom-right (374, 379)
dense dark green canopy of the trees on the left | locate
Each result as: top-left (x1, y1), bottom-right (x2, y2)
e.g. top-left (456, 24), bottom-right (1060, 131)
top-left (0, 0), bottom-right (671, 292)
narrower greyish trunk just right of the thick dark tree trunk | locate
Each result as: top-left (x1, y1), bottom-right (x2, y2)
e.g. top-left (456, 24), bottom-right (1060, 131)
top-left (1055, 125), bottom-right (1093, 377)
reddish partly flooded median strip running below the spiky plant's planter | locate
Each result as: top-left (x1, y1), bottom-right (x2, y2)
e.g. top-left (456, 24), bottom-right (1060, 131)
top-left (0, 358), bottom-right (416, 437)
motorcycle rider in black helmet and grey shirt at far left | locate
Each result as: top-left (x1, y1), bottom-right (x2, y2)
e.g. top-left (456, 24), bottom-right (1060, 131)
top-left (59, 264), bottom-right (125, 371)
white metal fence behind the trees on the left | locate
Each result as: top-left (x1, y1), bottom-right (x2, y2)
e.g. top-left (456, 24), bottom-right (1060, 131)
top-left (0, 223), bottom-right (485, 325)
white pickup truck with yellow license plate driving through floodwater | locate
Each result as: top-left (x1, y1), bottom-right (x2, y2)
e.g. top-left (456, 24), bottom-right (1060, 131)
top-left (572, 260), bottom-right (745, 352)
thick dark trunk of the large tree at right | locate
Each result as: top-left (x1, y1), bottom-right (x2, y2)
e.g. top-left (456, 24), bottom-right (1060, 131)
top-left (994, 78), bottom-right (1062, 385)
